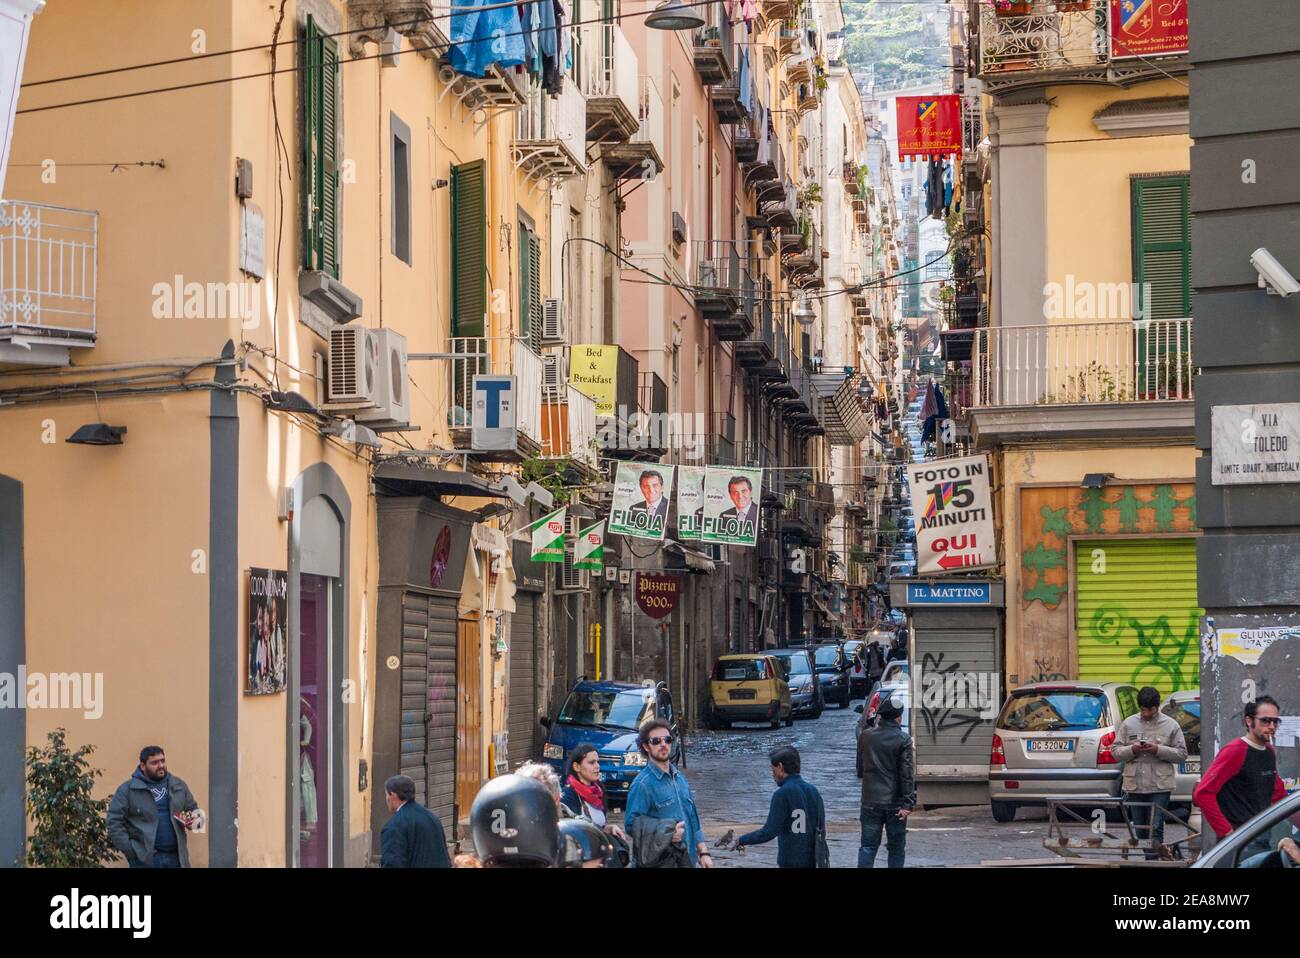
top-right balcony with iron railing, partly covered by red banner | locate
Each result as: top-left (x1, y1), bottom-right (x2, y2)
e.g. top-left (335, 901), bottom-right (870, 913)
top-left (978, 0), bottom-right (1187, 92)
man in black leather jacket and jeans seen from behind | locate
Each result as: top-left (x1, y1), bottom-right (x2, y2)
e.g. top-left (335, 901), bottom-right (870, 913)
top-left (858, 695), bottom-right (917, 868)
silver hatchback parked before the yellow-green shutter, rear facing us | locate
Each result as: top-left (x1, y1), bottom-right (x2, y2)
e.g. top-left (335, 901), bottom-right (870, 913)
top-left (988, 682), bottom-right (1138, 822)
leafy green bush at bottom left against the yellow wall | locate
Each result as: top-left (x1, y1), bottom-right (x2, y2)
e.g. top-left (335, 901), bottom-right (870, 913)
top-left (26, 728), bottom-right (117, 868)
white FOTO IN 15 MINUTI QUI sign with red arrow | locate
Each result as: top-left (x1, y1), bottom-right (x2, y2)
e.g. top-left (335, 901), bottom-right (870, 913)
top-left (907, 456), bottom-right (997, 576)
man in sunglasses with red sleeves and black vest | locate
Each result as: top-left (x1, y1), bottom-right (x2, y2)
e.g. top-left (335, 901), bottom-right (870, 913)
top-left (1192, 695), bottom-right (1287, 850)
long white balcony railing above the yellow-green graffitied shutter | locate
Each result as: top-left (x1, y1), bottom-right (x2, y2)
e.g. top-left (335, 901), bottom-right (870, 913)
top-left (971, 318), bottom-right (1195, 408)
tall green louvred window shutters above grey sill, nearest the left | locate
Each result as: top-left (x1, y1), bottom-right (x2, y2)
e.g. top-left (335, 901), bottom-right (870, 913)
top-left (302, 17), bottom-right (339, 279)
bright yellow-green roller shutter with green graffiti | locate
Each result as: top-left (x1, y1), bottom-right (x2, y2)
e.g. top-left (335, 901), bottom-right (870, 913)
top-left (1074, 538), bottom-right (1201, 694)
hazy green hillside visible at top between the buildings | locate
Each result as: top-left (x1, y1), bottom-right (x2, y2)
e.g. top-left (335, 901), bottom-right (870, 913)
top-left (842, 0), bottom-right (948, 90)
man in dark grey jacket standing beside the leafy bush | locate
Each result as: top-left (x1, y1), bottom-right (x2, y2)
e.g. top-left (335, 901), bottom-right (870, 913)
top-left (108, 745), bottom-right (204, 868)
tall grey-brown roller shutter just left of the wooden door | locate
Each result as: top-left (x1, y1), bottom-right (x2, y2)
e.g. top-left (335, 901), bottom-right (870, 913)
top-left (399, 591), bottom-right (456, 838)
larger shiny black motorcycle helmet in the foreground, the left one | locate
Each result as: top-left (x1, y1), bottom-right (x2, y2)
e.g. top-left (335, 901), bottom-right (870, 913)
top-left (469, 775), bottom-right (560, 868)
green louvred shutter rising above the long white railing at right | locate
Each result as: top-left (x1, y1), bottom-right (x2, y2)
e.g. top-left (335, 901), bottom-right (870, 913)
top-left (1132, 175), bottom-right (1192, 320)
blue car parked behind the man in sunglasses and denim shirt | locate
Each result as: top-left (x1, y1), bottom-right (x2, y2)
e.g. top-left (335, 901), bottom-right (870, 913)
top-left (542, 681), bottom-right (686, 805)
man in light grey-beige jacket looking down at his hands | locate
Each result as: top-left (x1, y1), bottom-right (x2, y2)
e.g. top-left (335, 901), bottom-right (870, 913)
top-left (1110, 685), bottom-right (1187, 859)
